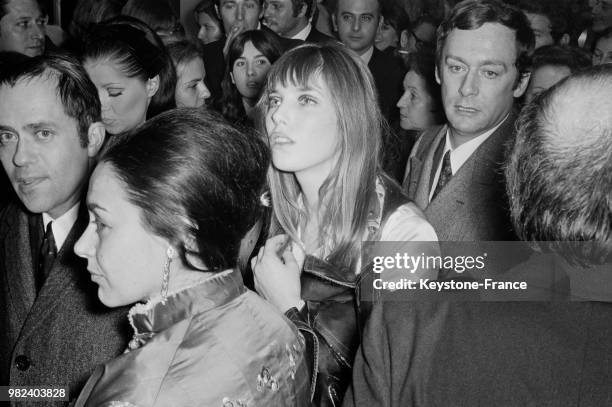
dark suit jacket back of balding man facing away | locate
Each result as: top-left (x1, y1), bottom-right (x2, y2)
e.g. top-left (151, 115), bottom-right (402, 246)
top-left (344, 292), bottom-right (612, 407)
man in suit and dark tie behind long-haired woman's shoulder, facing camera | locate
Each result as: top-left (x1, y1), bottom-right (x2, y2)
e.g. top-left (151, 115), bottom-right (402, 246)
top-left (403, 0), bottom-right (534, 241)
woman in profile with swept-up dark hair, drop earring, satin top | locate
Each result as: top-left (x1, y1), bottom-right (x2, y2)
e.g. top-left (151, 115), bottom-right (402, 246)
top-left (75, 109), bottom-right (308, 407)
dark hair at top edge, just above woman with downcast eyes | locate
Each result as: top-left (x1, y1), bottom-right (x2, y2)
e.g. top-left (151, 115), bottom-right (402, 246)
top-left (121, 0), bottom-right (185, 42)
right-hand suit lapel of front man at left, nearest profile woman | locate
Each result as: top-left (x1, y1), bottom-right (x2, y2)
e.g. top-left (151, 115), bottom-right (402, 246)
top-left (16, 207), bottom-right (87, 337)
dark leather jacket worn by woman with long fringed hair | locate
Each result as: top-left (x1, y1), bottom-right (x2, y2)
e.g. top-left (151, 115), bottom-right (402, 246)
top-left (285, 176), bottom-right (408, 406)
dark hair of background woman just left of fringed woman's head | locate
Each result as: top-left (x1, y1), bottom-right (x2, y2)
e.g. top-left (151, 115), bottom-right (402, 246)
top-left (215, 30), bottom-right (283, 123)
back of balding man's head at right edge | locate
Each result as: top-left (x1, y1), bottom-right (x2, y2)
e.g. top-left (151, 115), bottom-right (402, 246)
top-left (506, 65), bottom-right (612, 263)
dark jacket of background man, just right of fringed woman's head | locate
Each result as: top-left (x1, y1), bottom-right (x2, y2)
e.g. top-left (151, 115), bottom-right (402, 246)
top-left (368, 47), bottom-right (404, 123)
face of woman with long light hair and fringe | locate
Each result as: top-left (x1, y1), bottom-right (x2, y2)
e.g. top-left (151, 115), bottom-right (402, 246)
top-left (266, 76), bottom-right (342, 179)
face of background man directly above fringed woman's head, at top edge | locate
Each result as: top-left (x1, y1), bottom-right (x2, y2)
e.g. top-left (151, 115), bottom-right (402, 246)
top-left (333, 0), bottom-right (381, 55)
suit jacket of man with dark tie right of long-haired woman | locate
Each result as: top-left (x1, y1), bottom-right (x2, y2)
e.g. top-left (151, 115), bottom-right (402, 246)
top-left (403, 114), bottom-right (516, 241)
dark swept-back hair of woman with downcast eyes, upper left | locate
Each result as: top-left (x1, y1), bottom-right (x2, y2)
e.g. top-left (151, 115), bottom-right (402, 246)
top-left (81, 16), bottom-right (176, 119)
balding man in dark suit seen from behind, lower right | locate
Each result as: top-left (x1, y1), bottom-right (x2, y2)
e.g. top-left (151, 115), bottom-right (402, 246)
top-left (345, 65), bottom-right (612, 407)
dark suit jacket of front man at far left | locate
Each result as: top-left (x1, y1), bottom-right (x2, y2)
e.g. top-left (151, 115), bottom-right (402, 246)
top-left (0, 204), bottom-right (129, 405)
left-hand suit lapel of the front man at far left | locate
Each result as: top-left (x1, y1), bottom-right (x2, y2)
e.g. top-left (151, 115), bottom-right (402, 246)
top-left (2, 206), bottom-right (36, 335)
